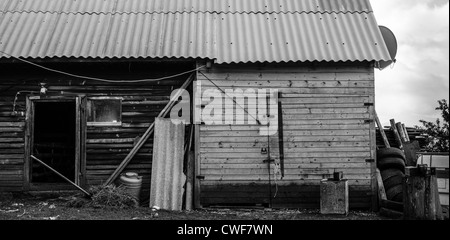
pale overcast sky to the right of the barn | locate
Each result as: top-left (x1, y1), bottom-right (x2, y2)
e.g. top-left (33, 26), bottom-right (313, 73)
top-left (371, 0), bottom-right (449, 127)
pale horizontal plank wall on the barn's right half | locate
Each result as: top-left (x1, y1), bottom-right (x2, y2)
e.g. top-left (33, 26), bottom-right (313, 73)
top-left (198, 63), bottom-right (375, 208)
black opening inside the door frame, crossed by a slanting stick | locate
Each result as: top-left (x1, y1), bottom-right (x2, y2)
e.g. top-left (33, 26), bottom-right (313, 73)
top-left (31, 101), bottom-right (76, 183)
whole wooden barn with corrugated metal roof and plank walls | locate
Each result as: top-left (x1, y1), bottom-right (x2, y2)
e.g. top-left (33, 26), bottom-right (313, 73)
top-left (0, 0), bottom-right (391, 208)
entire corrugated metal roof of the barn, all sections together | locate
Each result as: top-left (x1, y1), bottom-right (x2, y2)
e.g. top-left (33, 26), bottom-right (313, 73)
top-left (0, 0), bottom-right (390, 63)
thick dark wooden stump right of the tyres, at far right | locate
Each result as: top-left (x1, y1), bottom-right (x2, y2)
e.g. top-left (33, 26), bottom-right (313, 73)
top-left (403, 165), bottom-right (443, 220)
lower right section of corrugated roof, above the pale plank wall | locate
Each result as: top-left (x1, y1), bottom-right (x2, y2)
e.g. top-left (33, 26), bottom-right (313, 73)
top-left (217, 13), bottom-right (385, 62)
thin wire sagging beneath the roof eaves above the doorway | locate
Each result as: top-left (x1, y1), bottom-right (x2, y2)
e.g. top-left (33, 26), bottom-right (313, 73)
top-left (0, 50), bottom-right (206, 83)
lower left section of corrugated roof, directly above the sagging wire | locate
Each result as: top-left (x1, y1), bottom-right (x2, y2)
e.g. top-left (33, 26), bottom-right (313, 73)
top-left (0, 12), bottom-right (215, 59)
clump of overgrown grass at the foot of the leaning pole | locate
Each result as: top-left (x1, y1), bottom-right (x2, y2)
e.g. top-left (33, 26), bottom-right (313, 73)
top-left (67, 184), bottom-right (139, 208)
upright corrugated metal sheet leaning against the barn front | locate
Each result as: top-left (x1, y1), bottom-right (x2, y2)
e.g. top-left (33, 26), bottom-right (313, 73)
top-left (150, 118), bottom-right (186, 210)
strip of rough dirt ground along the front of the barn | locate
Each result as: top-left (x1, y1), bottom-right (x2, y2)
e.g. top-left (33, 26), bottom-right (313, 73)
top-left (0, 190), bottom-right (389, 220)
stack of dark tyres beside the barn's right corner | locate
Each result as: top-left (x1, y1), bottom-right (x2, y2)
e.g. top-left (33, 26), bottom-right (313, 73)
top-left (377, 148), bottom-right (405, 202)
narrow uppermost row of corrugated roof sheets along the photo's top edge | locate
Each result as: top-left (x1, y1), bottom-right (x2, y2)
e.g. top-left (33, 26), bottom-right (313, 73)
top-left (0, 0), bottom-right (372, 14)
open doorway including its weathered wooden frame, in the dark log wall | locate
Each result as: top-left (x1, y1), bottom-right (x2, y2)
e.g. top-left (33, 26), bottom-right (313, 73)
top-left (25, 96), bottom-right (85, 190)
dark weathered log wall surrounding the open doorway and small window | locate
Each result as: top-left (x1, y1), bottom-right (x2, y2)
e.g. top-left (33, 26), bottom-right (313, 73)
top-left (0, 61), bottom-right (194, 199)
